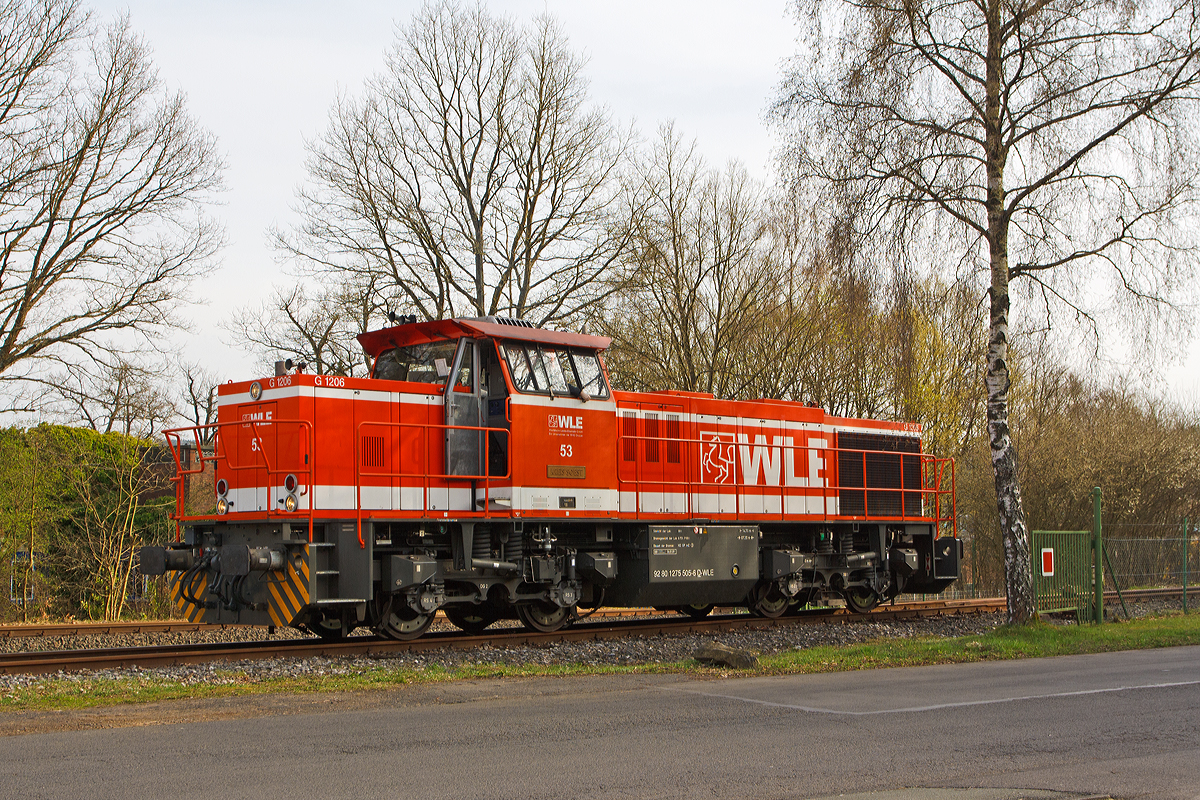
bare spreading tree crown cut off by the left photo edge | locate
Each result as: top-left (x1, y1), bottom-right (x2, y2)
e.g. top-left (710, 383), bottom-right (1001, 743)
top-left (0, 0), bottom-right (221, 407)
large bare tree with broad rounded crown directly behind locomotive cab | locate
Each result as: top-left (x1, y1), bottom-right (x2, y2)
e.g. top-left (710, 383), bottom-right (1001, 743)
top-left (278, 0), bottom-right (628, 324)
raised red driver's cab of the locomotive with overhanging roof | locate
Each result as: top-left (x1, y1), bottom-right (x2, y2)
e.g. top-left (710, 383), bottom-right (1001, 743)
top-left (359, 318), bottom-right (614, 517)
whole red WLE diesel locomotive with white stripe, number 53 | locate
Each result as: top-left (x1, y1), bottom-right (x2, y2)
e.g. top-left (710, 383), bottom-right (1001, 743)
top-left (142, 318), bottom-right (961, 638)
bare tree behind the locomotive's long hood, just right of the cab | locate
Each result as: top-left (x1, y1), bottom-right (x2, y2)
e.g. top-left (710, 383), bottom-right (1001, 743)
top-left (590, 125), bottom-right (787, 397)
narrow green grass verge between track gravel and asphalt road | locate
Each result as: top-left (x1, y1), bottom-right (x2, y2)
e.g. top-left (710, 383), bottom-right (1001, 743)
top-left (0, 614), bottom-right (1200, 711)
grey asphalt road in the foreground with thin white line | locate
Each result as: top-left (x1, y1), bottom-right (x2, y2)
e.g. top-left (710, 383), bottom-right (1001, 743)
top-left (0, 648), bottom-right (1200, 800)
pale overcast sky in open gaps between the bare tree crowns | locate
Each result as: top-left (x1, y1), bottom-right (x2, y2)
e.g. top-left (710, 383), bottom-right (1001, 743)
top-left (91, 0), bottom-right (797, 379)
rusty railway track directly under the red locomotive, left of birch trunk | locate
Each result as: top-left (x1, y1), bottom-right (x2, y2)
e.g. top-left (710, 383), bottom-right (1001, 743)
top-left (0, 599), bottom-right (1004, 674)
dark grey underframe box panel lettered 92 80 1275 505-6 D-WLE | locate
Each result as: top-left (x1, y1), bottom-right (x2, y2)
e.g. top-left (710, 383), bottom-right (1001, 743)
top-left (649, 525), bottom-right (758, 583)
